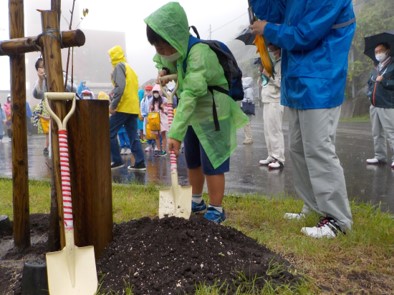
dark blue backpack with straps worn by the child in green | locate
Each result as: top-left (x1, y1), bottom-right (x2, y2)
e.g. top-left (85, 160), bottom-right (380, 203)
top-left (183, 26), bottom-right (244, 130)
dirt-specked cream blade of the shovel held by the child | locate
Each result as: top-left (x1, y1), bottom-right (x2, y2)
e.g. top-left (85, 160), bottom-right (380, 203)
top-left (159, 185), bottom-right (192, 219)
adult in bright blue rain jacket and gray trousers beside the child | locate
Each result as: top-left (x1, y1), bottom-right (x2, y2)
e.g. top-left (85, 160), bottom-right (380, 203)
top-left (249, 0), bottom-right (356, 238)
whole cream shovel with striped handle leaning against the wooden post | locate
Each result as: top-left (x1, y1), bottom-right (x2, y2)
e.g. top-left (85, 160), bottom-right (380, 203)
top-left (44, 92), bottom-right (97, 295)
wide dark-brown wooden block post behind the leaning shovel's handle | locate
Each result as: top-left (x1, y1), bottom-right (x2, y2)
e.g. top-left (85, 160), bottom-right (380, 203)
top-left (68, 100), bottom-right (113, 257)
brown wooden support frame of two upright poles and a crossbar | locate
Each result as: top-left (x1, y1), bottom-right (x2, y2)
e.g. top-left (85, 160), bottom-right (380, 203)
top-left (5, 0), bottom-right (85, 248)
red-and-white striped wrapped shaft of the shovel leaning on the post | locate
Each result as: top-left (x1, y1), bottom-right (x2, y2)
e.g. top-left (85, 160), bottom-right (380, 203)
top-left (58, 129), bottom-right (74, 230)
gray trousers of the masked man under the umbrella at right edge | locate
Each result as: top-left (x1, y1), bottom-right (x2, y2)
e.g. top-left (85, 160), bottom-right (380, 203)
top-left (369, 106), bottom-right (394, 162)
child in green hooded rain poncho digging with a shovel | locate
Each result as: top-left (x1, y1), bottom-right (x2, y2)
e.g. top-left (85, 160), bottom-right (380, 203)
top-left (145, 2), bottom-right (248, 223)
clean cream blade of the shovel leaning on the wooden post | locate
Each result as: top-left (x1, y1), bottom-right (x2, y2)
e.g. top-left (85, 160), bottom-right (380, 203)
top-left (46, 246), bottom-right (98, 295)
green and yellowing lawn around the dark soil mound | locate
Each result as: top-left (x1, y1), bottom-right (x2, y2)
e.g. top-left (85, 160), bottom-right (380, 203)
top-left (0, 179), bottom-right (394, 294)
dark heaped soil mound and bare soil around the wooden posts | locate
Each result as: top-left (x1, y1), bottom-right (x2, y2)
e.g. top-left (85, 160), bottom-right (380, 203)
top-left (0, 214), bottom-right (300, 294)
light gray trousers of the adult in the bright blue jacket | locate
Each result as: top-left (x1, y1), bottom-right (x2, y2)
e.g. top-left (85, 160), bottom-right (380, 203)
top-left (289, 107), bottom-right (353, 230)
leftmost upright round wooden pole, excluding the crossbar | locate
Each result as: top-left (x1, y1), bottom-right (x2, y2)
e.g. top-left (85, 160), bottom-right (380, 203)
top-left (9, 0), bottom-right (30, 248)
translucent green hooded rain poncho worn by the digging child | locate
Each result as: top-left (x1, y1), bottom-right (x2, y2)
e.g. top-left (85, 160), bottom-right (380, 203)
top-left (145, 2), bottom-right (249, 168)
